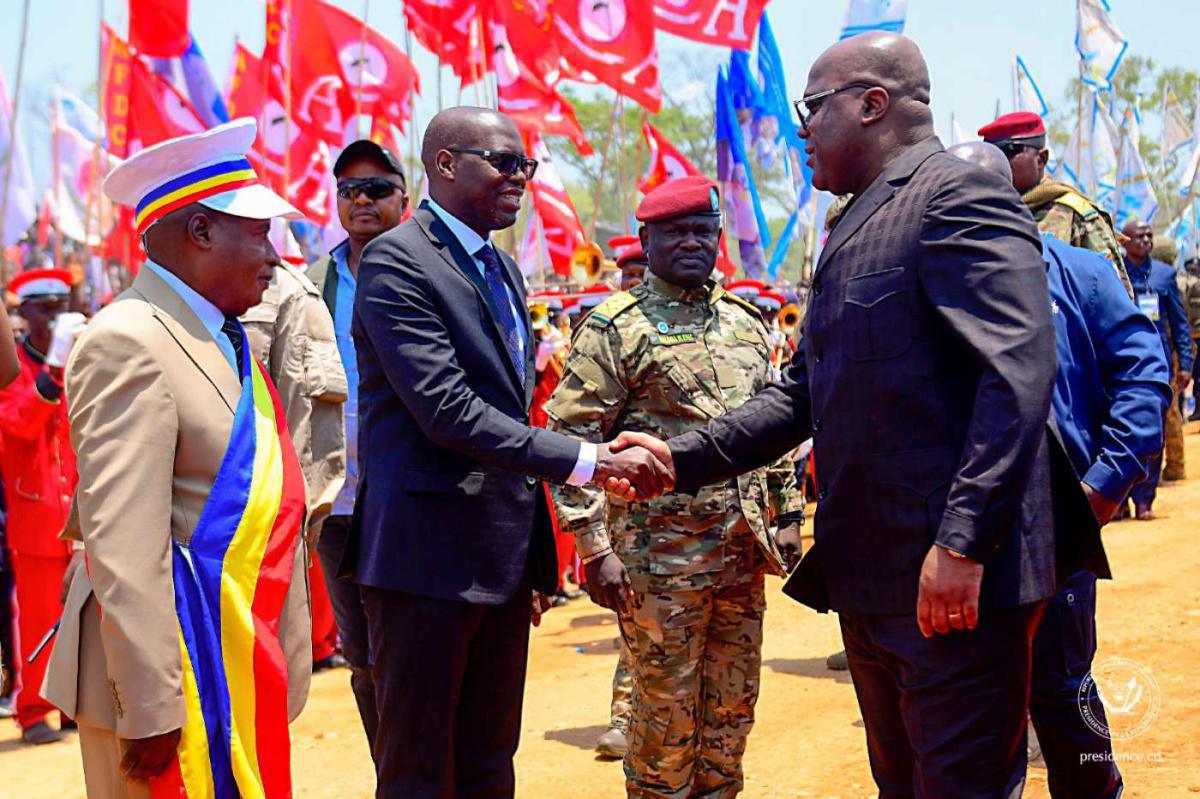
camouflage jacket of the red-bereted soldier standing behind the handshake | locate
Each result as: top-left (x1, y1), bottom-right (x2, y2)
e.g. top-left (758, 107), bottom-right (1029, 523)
top-left (546, 275), bottom-right (804, 590)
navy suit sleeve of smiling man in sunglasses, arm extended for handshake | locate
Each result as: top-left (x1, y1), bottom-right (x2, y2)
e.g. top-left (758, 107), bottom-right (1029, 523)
top-left (355, 233), bottom-right (580, 482)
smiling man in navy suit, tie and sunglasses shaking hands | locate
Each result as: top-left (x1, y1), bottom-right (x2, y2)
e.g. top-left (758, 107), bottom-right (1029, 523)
top-left (342, 108), bottom-right (665, 799)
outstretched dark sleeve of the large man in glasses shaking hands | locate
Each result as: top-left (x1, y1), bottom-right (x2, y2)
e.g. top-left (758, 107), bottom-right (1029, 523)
top-left (667, 341), bottom-right (812, 491)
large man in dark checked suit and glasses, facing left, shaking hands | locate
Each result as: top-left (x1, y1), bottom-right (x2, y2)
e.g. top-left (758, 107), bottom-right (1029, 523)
top-left (601, 34), bottom-right (1055, 799)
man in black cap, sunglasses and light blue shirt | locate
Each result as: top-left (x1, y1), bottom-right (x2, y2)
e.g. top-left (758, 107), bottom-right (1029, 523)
top-left (308, 139), bottom-right (408, 755)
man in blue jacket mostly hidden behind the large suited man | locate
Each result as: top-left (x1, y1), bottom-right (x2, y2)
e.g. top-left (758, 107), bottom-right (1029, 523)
top-left (949, 142), bottom-right (1174, 799)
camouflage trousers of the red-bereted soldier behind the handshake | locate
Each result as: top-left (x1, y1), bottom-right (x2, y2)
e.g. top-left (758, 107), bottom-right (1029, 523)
top-left (620, 569), bottom-right (767, 799)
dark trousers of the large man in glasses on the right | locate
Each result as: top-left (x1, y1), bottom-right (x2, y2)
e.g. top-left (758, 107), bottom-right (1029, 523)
top-left (841, 602), bottom-right (1045, 799)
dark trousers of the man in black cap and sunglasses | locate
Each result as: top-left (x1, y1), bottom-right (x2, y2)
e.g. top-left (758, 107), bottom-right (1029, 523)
top-left (317, 516), bottom-right (379, 757)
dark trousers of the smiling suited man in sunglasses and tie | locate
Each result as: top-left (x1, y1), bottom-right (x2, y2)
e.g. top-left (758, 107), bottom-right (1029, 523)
top-left (361, 581), bottom-right (532, 799)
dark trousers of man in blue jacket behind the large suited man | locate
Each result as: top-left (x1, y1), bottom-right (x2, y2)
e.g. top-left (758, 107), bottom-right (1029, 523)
top-left (1030, 571), bottom-right (1122, 799)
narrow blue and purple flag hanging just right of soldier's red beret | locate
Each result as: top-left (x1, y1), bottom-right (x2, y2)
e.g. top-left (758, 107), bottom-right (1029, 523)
top-left (716, 67), bottom-right (770, 278)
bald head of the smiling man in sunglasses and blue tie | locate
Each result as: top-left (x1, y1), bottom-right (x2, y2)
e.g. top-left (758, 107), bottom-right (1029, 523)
top-left (421, 106), bottom-right (528, 238)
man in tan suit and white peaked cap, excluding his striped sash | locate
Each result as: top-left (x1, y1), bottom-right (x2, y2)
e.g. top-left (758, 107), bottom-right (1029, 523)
top-left (43, 119), bottom-right (311, 798)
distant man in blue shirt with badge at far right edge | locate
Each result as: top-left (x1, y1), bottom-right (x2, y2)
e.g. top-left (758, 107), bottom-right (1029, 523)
top-left (1122, 220), bottom-right (1192, 521)
